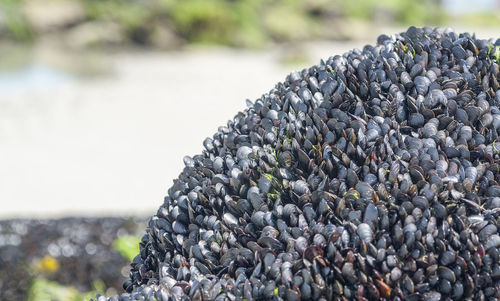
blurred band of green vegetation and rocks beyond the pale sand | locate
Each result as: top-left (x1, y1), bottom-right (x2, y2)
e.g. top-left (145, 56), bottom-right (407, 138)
top-left (0, 0), bottom-right (452, 47)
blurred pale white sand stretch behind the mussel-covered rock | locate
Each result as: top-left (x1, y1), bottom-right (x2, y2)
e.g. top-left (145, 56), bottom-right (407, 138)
top-left (0, 43), bottom-right (368, 218)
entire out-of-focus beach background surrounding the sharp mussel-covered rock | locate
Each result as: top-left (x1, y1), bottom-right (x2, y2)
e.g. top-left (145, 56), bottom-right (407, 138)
top-left (0, 0), bottom-right (500, 300)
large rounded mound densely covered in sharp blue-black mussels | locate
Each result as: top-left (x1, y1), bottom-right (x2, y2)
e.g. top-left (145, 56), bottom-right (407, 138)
top-left (98, 27), bottom-right (500, 300)
